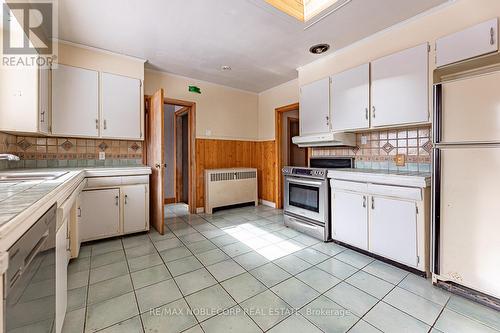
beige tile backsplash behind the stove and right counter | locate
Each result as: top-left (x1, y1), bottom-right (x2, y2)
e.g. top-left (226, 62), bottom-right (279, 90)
top-left (312, 126), bottom-right (432, 172)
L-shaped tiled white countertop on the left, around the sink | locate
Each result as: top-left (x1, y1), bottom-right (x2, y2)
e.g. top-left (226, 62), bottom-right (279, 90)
top-left (0, 166), bottom-right (151, 251)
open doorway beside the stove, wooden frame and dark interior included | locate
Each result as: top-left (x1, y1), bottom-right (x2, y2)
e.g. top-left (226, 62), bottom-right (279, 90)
top-left (275, 103), bottom-right (309, 208)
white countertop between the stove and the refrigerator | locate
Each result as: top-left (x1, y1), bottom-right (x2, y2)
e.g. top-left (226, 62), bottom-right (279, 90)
top-left (328, 169), bottom-right (431, 188)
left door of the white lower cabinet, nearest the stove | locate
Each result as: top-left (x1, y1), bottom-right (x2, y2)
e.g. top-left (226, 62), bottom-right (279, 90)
top-left (332, 192), bottom-right (368, 250)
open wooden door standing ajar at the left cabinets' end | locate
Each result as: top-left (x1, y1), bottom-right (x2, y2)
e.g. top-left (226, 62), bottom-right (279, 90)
top-left (147, 89), bottom-right (165, 235)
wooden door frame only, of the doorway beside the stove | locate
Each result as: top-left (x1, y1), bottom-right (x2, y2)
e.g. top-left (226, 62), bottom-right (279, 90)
top-left (274, 103), bottom-right (300, 208)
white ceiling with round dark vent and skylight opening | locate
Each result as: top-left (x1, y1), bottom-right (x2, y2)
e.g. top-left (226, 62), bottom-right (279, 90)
top-left (59, 0), bottom-right (447, 92)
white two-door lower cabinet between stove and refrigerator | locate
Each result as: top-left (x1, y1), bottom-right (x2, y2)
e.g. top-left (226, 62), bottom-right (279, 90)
top-left (331, 180), bottom-right (428, 271)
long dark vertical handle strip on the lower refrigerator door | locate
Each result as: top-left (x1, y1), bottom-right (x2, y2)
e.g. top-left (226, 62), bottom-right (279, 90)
top-left (431, 148), bottom-right (441, 275)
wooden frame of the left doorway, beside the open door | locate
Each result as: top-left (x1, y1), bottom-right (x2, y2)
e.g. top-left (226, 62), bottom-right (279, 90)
top-left (163, 98), bottom-right (197, 214)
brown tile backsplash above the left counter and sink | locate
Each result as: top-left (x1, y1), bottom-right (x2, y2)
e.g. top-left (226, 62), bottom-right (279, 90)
top-left (0, 132), bottom-right (143, 169)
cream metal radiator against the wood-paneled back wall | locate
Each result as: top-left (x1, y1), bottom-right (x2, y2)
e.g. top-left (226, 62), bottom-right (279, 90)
top-left (205, 168), bottom-right (258, 214)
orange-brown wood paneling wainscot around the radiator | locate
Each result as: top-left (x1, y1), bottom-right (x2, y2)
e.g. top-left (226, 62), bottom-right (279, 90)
top-left (196, 139), bottom-right (276, 207)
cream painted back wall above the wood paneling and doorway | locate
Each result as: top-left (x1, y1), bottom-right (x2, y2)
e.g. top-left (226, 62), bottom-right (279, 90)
top-left (144, 70), bottom-right (259, 140)
